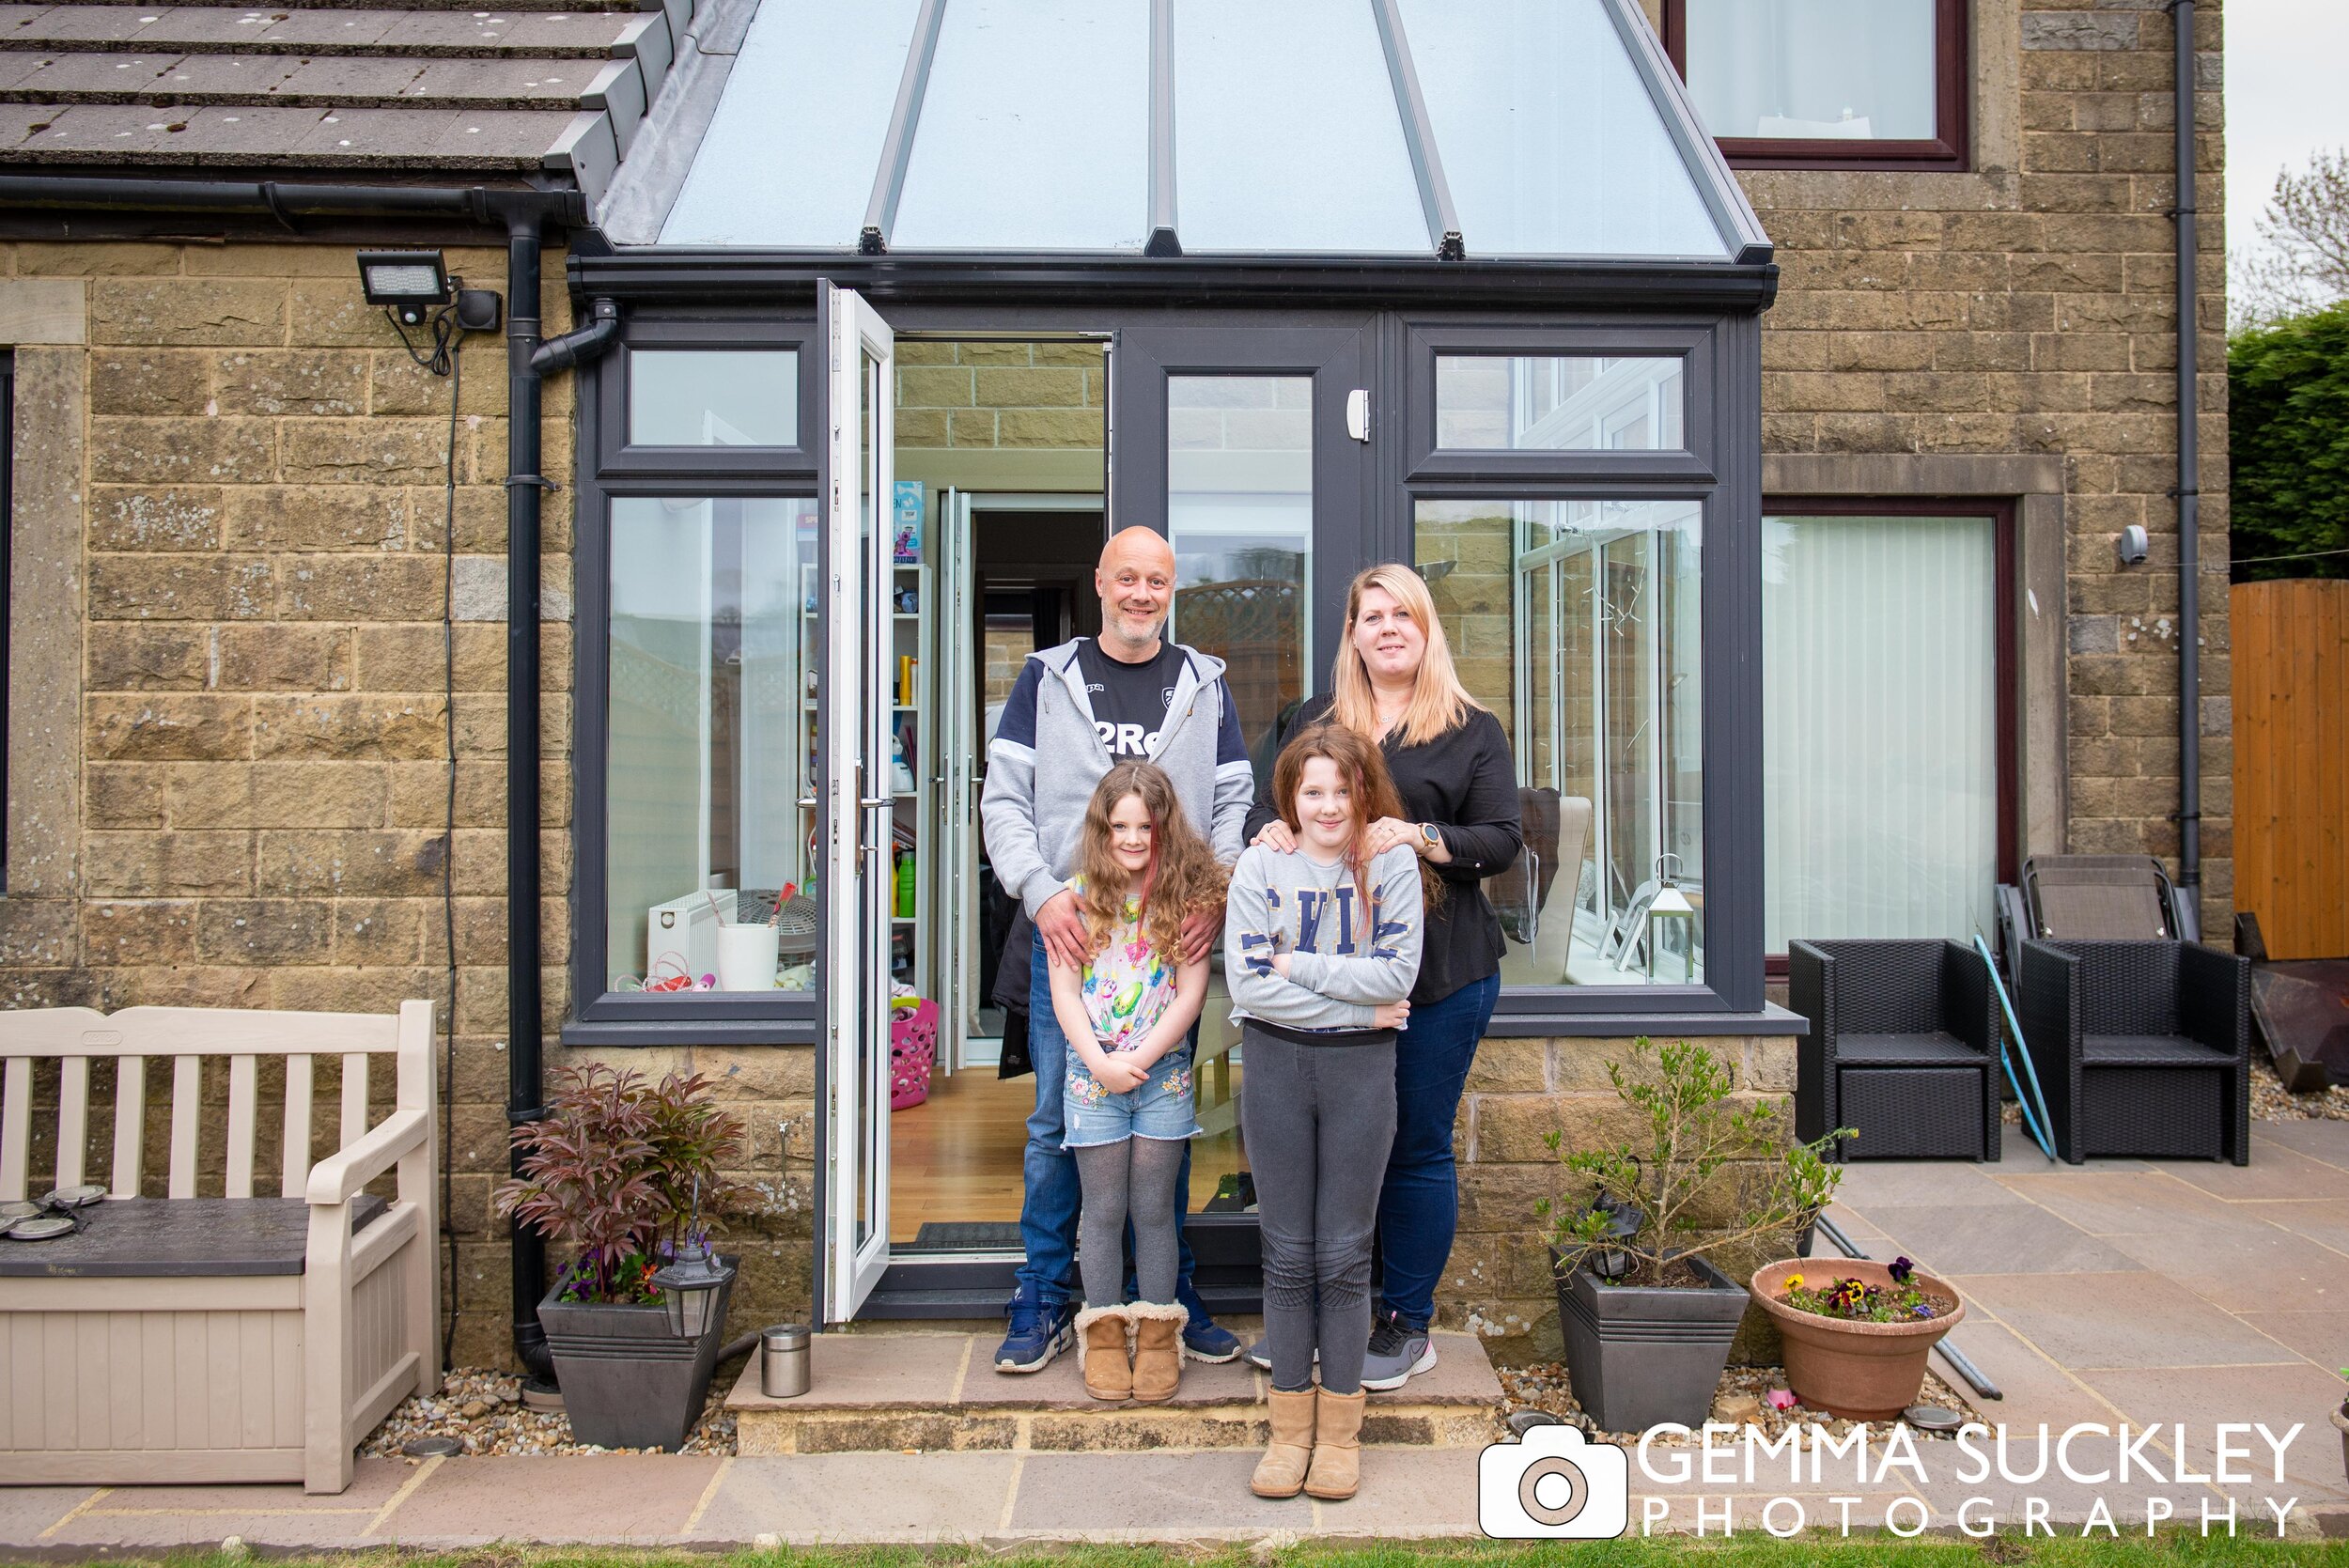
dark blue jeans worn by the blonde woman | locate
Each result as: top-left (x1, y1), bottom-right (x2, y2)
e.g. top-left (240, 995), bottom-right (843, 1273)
top-left (1379, 974), bottom-right (1501, 1327)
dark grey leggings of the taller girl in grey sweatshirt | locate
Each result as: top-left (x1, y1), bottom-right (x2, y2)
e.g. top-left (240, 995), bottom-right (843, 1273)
top-left (1240, 1028), bottom-right (1395, 1394)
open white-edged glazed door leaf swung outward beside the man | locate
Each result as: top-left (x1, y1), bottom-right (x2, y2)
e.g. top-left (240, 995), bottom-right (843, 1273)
top-left (822, 288), bottom-right (897, 1324)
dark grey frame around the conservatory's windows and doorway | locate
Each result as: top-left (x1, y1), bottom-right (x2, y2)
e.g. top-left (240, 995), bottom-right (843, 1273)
top-left (564, 275), bottom-right (1785, 1047)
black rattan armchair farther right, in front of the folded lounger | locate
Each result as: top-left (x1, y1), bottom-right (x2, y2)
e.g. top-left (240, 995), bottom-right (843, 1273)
top-left (2023, 941), bottom-right (2250, 1164)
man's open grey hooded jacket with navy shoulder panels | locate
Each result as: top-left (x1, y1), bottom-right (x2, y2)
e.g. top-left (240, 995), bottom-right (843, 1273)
top-left (980, 639), bottom-right (1257, 920)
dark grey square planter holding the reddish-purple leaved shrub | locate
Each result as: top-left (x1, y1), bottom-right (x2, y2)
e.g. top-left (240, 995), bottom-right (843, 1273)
top-left (538, 1258), bottom-right (736, 1451)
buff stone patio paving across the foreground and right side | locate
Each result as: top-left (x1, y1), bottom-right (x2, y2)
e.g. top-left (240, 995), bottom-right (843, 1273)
top-left (0, 1122), bottom-right (2349, 1557)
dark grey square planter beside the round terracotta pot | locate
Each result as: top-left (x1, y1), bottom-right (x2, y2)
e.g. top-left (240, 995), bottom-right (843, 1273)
top-left (1550, 1251), bottom-right (1746, 1432)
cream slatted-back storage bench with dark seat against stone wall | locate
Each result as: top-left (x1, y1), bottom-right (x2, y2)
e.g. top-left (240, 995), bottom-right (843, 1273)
top-left (0, 1002), bottom-right (440, 1493)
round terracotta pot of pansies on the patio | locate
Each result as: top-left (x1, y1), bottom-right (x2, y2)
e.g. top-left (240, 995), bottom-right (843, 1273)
top-left (1752, 1258), bottom-right (1967, 1421)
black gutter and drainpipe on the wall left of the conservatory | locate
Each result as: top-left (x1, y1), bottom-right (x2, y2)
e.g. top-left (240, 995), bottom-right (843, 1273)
top-left (0, 174), bottom-right (597, 1378)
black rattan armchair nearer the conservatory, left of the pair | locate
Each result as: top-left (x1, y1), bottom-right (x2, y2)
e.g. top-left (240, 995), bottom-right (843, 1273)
top-left (1785, 941), bottom-right (1999, 1159)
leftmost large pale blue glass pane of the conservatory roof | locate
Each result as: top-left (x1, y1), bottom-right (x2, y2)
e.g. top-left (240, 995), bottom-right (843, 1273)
top-left (661, 0), bottom-right (921, 249)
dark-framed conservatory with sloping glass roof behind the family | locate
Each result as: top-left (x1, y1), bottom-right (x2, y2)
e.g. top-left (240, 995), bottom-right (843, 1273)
top-left (564, 0), bottom-right (1785, 1322)
